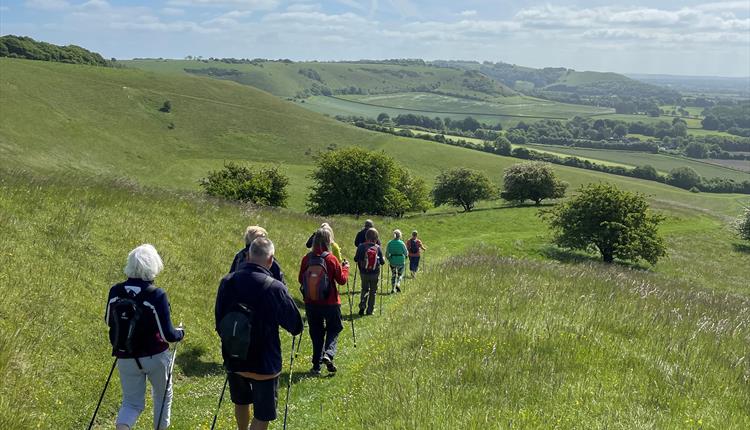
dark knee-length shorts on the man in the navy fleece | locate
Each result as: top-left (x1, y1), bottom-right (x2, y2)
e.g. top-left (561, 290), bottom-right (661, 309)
top-left (229, 372), bottom-right (279, 421)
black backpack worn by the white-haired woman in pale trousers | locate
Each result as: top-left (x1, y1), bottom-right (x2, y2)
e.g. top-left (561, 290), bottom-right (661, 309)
top-left (107, 284), bottom-right (156, 357)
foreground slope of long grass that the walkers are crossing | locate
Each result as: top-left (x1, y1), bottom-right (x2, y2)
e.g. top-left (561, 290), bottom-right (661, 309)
top-left (0, 172), bottom-right (750, 430)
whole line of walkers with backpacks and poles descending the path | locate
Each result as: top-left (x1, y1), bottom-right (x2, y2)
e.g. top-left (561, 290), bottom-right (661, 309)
top-left (98, 220), bottom-right (427, 430)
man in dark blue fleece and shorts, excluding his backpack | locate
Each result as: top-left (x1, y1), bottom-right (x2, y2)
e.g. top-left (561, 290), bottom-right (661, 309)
top-left (215, 237), bottom-right (303, 430)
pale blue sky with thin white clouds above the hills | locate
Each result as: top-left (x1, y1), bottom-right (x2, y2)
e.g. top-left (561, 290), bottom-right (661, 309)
top-left (0, 0), bottom-right (750, 77)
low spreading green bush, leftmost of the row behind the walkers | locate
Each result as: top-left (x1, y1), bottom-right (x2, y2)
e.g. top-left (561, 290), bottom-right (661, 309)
top-left (200, 163), bottom-right (289, 207)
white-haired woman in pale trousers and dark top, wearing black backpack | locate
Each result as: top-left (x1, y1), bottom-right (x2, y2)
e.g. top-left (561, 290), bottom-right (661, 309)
top-left (105, 244), bottom-right (185, 430)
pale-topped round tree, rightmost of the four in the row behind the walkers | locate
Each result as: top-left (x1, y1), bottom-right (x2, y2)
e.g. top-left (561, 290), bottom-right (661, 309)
top-left (500, 161), bottom-right (568, 205)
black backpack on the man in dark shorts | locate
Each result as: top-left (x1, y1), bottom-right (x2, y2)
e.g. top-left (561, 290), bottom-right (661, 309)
top-left (219, 276), bottom-right (274, 365)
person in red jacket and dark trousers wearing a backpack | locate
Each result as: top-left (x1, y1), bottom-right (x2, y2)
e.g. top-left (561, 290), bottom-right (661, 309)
top-left (299, 228), bottom-right (349, 375)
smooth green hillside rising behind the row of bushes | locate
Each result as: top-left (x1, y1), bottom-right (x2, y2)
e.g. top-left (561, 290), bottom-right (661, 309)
top-left (0, 59), bottom-right (746, 215)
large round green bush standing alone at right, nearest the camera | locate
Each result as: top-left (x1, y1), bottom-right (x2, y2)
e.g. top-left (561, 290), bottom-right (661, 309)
top-left (546, 184), bottom-right (666, 264)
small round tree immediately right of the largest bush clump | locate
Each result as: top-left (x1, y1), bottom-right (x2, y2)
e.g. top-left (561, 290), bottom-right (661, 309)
top-left (432, 167), bottom-right (495, 212)
